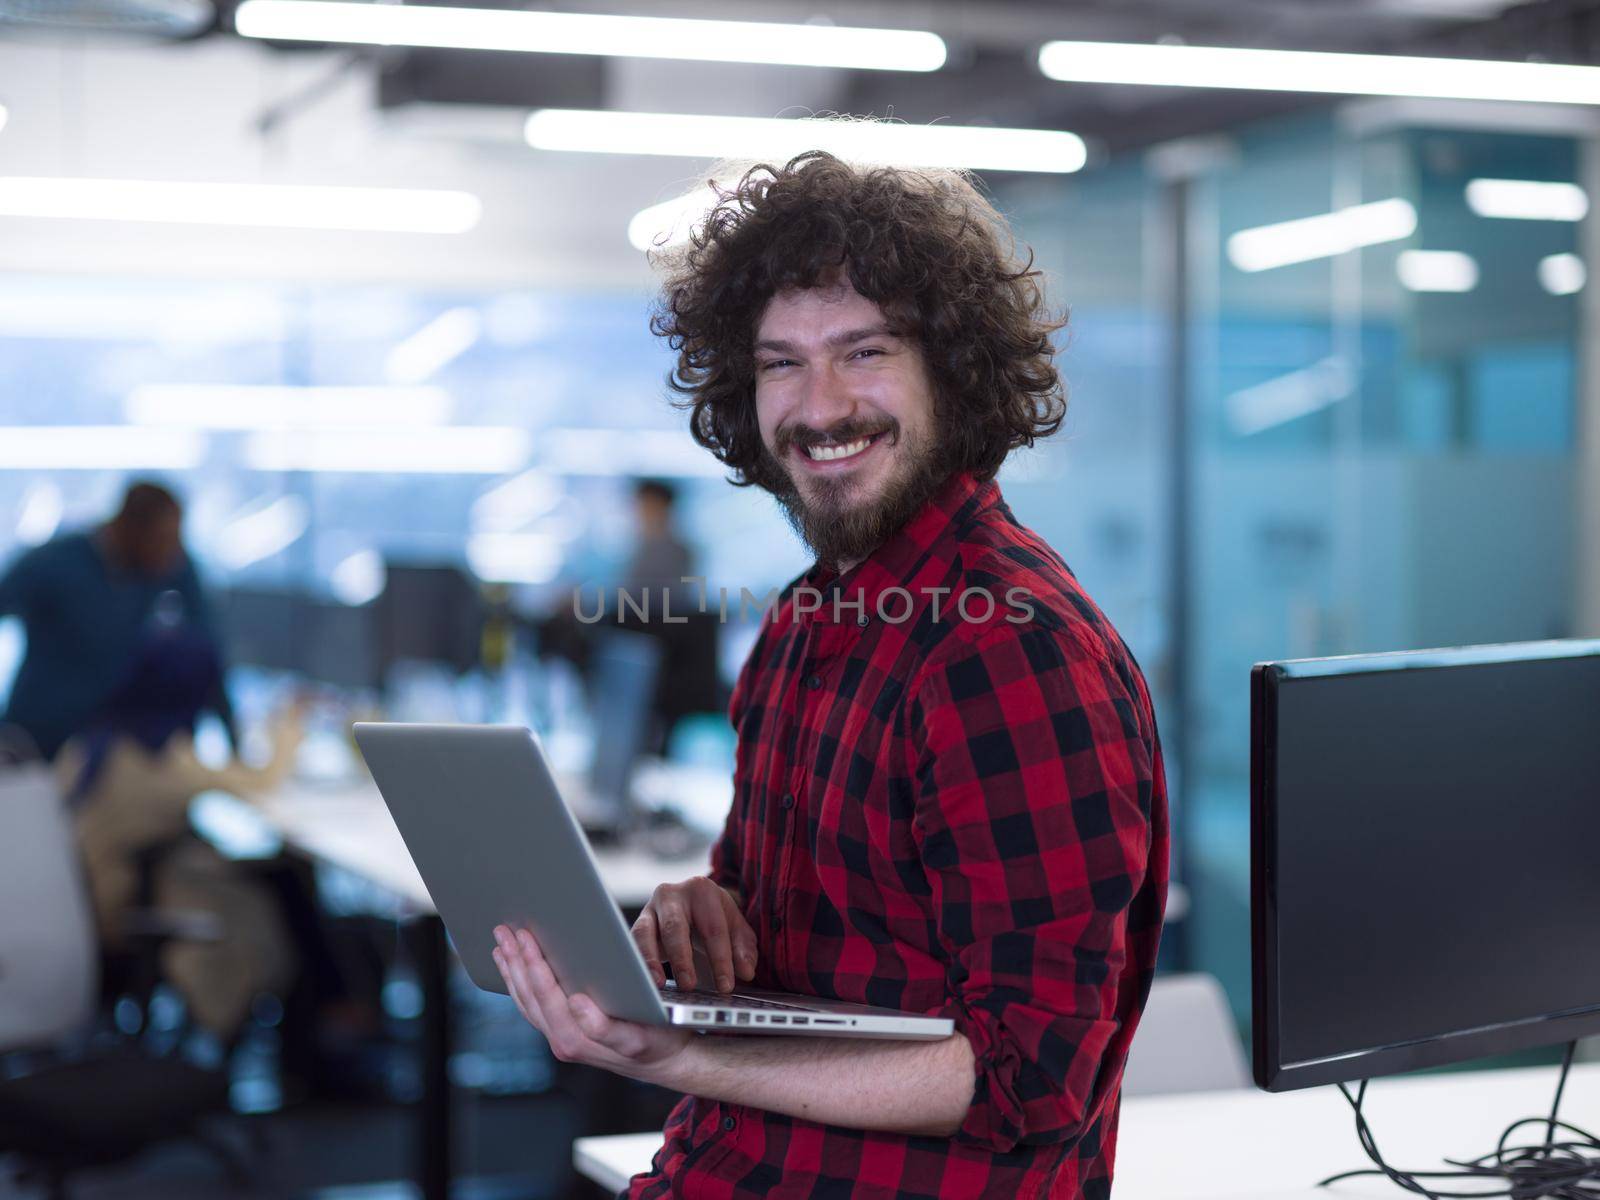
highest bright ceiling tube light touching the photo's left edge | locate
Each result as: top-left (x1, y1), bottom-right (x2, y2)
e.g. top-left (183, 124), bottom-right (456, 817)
top-left (0, 174), bottom-right (483, 234)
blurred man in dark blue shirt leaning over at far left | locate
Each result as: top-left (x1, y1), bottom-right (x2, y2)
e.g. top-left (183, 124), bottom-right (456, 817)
top-left (0, 483), bottom-right (232, 758)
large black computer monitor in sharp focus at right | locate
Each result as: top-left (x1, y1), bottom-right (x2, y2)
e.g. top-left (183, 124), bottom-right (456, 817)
top-left (1251, 642), bottom-right (1600, 1091)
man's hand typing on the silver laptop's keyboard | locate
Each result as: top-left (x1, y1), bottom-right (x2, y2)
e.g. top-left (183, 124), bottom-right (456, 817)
top-left (634, 875), bottom-right (755, 992)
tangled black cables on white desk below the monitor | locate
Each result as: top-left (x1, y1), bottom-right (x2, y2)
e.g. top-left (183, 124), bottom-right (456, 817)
top-left (1317, 1042), bottom-right (1600, 1200)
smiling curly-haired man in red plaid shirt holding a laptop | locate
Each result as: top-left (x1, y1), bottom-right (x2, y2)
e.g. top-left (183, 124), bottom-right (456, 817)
top-left (496, 154), bottom-right (1168, 1198)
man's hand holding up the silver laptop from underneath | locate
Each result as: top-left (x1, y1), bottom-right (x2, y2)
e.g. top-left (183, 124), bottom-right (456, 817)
top-left (494, 925), bottom-right (694, 1086)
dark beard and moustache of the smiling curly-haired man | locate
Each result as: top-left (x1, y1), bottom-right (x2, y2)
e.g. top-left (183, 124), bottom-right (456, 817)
top-left (766, 421), bottom-right (950, 566)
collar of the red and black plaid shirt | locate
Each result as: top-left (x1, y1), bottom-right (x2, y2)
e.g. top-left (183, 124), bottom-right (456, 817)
top-left (795, 470), bottom-right (1000, 626)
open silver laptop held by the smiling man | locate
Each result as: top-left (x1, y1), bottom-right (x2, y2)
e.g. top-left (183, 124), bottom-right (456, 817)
top-left (355, 722), bottom-right (954, 1040)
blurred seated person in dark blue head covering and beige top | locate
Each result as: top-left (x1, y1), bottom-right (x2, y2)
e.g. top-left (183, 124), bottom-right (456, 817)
top-left (54, 624), bottom-right (301, 1043)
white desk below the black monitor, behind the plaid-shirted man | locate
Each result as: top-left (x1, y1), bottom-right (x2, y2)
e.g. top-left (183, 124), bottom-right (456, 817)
top-left (573, 1062), bottom-right (1600, 1200)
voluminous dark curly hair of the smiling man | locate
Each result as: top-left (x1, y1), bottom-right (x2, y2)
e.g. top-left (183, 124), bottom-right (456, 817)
top-left (651, 150), bottom-right (1066, 491)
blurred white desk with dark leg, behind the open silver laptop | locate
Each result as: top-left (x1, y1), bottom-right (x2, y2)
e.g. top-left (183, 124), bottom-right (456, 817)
top-left (227, 778), bottom-right (709, 1200)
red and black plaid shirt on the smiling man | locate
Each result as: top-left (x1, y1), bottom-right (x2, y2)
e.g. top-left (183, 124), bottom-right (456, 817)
top-left (629, 475), bottom-right (1168, 1200)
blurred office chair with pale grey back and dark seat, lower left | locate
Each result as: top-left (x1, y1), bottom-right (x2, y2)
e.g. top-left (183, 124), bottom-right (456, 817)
top-left (0, 763), bottom-right (248, 1200)
